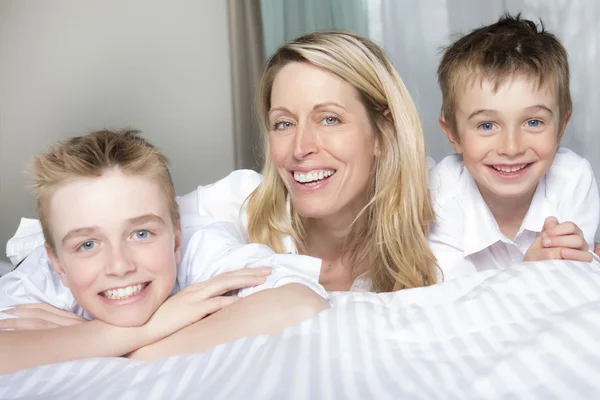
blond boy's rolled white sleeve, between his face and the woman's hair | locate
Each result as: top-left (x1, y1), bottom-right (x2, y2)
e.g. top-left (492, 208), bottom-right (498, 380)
top-left (178, 221), bottom-right (328, 299)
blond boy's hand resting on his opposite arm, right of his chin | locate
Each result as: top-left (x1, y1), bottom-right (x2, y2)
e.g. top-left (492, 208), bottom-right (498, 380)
top-left (145, 268), bottom-right (271, 342)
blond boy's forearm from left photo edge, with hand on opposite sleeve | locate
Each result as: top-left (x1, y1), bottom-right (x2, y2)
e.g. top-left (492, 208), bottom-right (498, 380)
top-left (0, 269), bottom-right (272, 374)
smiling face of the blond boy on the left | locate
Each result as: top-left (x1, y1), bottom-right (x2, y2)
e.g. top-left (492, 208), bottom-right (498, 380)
top-left (49, 169), bottom-right (181, 326)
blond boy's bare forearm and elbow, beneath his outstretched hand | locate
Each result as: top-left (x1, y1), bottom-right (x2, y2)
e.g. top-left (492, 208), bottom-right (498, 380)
top-left (130, 283), bottom-right (329, 361)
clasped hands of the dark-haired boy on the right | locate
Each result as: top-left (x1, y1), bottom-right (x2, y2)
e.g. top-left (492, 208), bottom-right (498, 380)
top-left (524, 217), bottom-right (593, 262)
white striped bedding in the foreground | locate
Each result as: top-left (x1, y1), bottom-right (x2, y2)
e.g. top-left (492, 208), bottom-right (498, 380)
top-left (0, 261), bottom-right (600, 399)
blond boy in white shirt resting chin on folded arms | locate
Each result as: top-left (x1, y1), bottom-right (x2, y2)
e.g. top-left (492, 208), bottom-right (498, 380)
top-left (0, 131), bottom-right (328, 374)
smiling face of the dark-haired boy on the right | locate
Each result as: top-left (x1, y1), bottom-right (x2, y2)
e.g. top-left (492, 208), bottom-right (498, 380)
top-left (442, 75), bottom-right (568, 208)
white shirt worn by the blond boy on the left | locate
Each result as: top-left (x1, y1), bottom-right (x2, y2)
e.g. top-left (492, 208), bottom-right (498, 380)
top-left (0, 203), bottom-right (328, 319)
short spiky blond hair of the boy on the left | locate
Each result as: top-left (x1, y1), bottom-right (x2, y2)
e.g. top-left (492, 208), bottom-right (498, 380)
top-left (31, 130), bottom-right (179, 251)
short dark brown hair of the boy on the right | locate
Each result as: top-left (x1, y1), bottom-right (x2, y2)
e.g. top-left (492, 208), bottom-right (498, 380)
top-left (437, 14), bottom-right (573, 136)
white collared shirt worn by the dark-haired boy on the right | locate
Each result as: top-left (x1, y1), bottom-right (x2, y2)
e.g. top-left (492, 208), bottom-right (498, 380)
top-left (429, 147), bottom-right (600, 280)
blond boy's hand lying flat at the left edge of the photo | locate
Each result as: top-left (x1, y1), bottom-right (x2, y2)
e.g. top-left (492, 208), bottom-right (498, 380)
top-left (0, 303), bottom-right (88, 331)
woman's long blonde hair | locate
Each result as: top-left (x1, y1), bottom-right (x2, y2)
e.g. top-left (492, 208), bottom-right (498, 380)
top-left (247, 31), bottom-right (436, 292)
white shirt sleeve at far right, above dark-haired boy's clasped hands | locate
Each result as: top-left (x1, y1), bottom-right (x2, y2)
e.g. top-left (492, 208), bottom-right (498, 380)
top-left (558, 159), bottom-right (600, 252)
